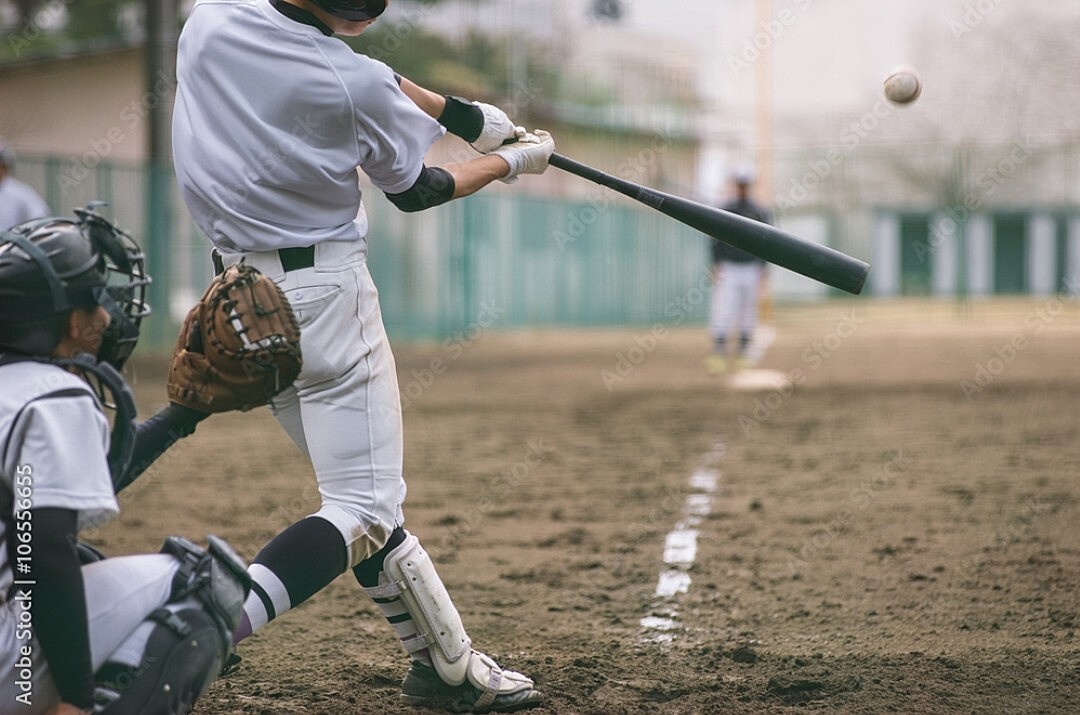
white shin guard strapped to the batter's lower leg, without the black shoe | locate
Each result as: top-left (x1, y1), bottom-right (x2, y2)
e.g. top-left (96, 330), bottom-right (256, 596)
top-left (375, 532), bottom-right (534, 699)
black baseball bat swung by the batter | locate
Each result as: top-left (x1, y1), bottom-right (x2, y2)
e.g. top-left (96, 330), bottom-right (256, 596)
top-left (549, 153), bottom-right (870, 294)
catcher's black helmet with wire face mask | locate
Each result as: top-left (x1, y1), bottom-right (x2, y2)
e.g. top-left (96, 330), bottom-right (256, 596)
top-left (0, 204), bottom-right (150, 369)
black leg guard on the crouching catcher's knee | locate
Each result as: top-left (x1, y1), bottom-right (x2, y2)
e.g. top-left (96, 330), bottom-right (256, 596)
top-left (94, 537), bottom-right (251, 715)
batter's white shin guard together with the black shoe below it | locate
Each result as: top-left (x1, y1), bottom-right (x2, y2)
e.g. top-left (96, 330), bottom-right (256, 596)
top-left (365, 531), bottom-right (540, 712)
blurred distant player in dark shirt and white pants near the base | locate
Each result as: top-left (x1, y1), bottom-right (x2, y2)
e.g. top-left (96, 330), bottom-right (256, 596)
top-left (707, 167), bottom-right (772, 373)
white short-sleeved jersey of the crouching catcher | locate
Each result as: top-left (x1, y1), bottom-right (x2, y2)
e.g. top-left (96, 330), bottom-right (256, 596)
top-left (0, 362), bottom-right (120, 600)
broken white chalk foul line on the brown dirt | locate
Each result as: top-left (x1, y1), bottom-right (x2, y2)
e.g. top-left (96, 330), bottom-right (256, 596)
top-left (640, 455), bottom-right (724, 643)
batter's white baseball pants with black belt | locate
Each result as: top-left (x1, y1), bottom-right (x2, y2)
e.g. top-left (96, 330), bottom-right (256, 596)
top-left (225, 240), bottom-right (405, 568)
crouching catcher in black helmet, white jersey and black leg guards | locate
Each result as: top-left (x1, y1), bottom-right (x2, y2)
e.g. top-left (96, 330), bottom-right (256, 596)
top-left (0, 211), bottom-right (248, 715)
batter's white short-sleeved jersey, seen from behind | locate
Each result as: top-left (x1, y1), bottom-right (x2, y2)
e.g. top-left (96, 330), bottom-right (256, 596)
top-left (173, 0), bottom-right (444, 253)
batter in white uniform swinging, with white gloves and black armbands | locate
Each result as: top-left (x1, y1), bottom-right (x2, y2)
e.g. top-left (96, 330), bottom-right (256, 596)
top-left (173, 0), bottom-right (554, 712)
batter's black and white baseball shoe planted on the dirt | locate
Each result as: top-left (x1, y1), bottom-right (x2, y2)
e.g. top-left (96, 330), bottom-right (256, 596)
top-left (402, 661), bottom-right (542, 713)
